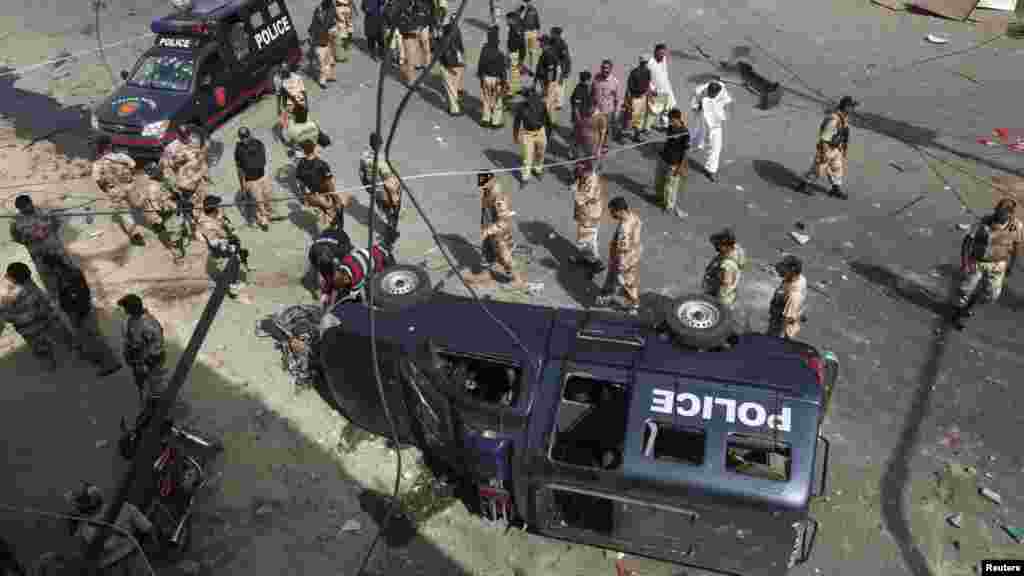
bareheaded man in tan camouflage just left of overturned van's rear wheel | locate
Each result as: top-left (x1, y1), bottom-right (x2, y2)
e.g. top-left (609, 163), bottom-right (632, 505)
top-left (597, 196), bottom-right (643, 316)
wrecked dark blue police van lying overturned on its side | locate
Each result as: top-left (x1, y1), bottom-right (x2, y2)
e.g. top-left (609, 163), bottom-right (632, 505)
top-left (321, 264), bottom-right (839, 576)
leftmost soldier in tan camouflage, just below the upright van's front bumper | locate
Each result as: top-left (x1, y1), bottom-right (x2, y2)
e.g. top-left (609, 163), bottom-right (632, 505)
top-left (92, 134), bottom-right (149, 245)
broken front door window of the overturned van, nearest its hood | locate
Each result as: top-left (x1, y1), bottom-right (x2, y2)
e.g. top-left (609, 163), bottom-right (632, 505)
top-left (437, 352), bottom-right (522, 406)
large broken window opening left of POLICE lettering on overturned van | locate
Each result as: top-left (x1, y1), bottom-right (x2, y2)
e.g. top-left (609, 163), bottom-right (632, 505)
top-left (550, 375), bottom-right (629, 469)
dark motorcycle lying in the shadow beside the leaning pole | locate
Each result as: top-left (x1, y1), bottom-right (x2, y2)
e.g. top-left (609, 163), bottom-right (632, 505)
top-left (118, 411), bottom-right (223, 560)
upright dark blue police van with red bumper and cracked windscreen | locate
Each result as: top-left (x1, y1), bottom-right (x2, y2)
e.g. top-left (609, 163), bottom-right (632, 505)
top-left (91, 0), bottom-right (302, 157)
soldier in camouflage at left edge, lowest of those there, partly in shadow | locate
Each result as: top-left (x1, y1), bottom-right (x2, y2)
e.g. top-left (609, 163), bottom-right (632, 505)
top-left (0, 262), bottom-right (71, 372)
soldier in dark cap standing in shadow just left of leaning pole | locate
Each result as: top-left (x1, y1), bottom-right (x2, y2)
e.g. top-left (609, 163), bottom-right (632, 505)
top-left (118, 294), bottom-right (167, 411)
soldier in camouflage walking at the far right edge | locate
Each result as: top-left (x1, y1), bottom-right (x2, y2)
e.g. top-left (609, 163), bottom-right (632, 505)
top-left (953, 198), bottom-right (1024, 330)
